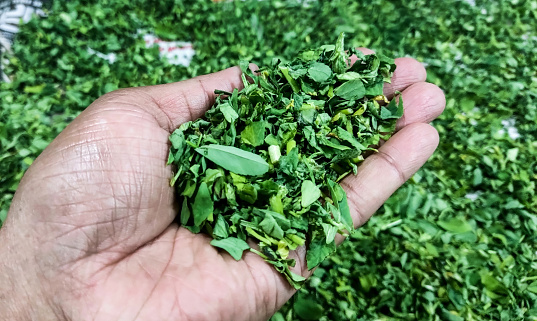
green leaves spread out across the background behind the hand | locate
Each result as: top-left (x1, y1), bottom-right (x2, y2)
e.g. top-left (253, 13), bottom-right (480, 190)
top-left (0, 0), bottom-right (537, 321)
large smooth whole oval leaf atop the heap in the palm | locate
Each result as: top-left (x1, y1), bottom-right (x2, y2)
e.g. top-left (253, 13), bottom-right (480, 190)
top-left (196, 145), bottom-right (269, 176)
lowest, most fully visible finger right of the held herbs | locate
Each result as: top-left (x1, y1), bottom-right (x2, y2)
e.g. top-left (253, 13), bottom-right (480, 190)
top-left (342, 123), bottom-right (438, 226)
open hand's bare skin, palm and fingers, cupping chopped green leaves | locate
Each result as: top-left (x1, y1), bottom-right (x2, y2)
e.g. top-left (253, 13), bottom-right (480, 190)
top-left (0, 49), bottom-right (445, 320)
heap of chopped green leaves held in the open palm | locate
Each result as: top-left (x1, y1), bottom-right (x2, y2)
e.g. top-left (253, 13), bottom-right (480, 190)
top-left (168, 34), bottom-right (403, 288)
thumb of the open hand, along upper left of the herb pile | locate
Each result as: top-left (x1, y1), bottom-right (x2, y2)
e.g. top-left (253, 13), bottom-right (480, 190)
top-left (139, 65), bottom-right (245, 132)
